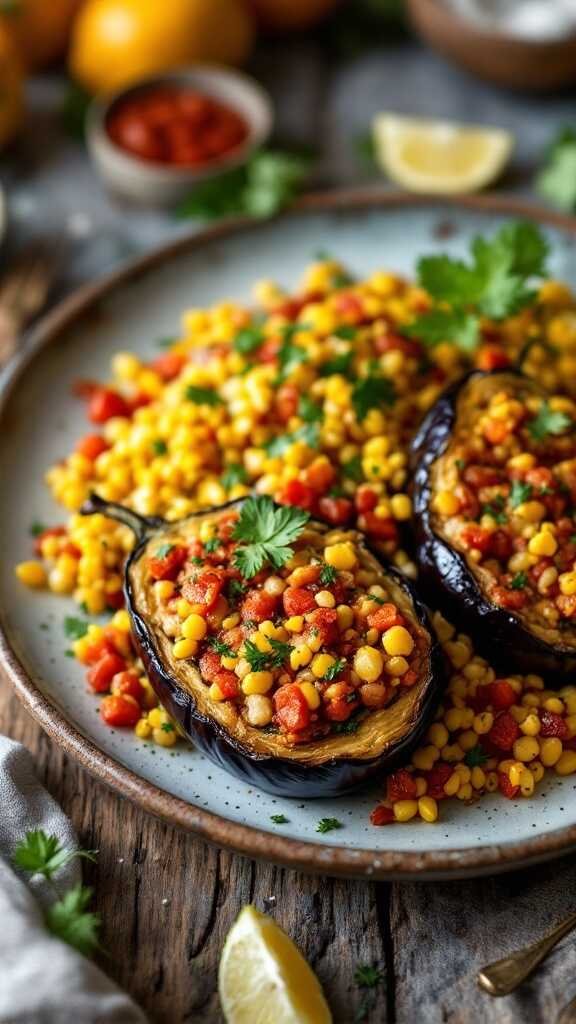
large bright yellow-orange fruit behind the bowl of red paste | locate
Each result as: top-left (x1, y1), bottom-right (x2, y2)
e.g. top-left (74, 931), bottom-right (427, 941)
top-left (70, 0), bottom-right (254, 93)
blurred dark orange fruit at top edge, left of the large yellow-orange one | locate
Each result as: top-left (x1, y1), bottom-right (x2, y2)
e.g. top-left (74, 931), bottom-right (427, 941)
top-left (0, 0), bottom-right (82, 68)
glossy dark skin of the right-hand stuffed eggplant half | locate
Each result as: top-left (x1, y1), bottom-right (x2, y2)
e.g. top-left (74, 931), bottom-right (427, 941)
top-left (411, 370), bottom-right (576, 685)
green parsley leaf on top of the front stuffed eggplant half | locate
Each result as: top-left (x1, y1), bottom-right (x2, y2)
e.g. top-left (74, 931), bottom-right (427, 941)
top-left (232, 495), bottom-right (310, 580)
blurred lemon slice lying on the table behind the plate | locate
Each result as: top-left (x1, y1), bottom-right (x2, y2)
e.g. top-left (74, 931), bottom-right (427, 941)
top-left (372, 114), bottom-right (513, 195)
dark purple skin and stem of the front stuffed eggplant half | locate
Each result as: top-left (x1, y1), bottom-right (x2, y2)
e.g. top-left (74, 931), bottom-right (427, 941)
top-left (82, 496), bottom-right (445, 798)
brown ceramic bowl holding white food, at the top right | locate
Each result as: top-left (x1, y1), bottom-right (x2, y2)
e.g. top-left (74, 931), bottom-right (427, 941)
top-left (408, 0), bottom-right (576, 91)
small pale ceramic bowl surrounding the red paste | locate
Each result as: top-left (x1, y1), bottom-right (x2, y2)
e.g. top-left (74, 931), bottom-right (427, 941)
top-left (87, 65), bottom-right (273, 206)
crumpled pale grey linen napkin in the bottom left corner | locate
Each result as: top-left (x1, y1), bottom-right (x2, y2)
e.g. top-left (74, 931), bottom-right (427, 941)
top-left (0, 736), bottom-right (146, 1024)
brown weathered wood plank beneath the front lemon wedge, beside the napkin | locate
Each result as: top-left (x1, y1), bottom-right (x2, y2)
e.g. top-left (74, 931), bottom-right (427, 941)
top-left (0, 681), bottom-right (387, 1024)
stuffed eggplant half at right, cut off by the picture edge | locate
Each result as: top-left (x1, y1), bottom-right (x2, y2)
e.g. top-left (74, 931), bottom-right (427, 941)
top-left (413, 372), bottom-right (576, 682)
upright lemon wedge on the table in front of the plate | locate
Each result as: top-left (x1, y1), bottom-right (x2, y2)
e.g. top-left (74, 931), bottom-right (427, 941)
top-left (218, 906), bottom-right (332, 1024)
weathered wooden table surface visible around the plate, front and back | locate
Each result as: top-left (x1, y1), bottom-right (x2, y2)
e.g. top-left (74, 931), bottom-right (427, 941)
top-left (5, 34), bottom-right (576, 1024)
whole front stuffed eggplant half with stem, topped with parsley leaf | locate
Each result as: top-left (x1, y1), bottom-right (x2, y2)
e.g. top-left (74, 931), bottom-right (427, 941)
top-left (83, 497), bottom-right (442, 797)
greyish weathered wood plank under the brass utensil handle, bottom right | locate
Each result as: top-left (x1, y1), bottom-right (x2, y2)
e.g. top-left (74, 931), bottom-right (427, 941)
top-left (390, 857), bottom-right (576, 1024)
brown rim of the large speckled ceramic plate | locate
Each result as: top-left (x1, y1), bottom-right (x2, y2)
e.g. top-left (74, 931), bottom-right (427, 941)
top-left (0, 186), bottom-right (576, 881)
